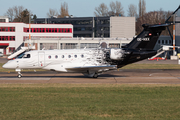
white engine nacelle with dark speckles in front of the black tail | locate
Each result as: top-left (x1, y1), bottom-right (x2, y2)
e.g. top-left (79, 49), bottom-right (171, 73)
top-left (110, 49), bottom-right (124, 60)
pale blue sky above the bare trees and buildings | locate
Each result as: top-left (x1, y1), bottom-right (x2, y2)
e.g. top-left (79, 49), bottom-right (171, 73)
top-left (0, 0), bottom-right (180, 18)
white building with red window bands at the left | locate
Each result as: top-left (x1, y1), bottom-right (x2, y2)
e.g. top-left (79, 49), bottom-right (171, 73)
top-left (0, 19), bottom-right (73, 55)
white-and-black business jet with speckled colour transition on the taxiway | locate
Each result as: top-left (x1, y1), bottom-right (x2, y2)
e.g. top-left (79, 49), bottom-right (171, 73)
top-left (3, 23), bottom-right (171, 78)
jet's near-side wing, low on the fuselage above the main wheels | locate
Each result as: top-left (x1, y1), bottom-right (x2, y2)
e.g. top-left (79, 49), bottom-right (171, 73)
top-left (66, 65), bottom-right (117, 72)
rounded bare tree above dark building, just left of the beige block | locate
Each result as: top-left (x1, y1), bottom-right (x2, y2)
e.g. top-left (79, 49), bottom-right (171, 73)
top-left (94, 3), bottom-right (109, 17)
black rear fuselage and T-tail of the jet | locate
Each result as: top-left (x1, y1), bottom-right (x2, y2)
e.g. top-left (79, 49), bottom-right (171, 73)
top-left (117, 23), bottom-right (171, 68)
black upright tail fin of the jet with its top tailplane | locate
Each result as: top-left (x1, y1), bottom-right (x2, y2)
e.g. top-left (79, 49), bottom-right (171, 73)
top-left (126, 24), bottom-right (170, 50)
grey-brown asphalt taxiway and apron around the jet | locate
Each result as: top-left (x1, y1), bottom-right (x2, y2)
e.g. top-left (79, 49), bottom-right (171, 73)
top-left (0, 58), bottom-right (180, 84)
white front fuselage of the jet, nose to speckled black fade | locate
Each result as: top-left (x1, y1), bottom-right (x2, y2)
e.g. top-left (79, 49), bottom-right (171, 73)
top-left (3, 49), bottom-right (107, 72)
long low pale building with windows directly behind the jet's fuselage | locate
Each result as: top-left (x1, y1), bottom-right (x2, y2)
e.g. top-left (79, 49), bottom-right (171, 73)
top-left (24, 37), bottom-right (132, 50)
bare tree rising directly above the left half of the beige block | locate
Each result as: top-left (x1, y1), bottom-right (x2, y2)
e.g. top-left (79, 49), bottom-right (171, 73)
top-left (109, 1), bottom-right (124, 16)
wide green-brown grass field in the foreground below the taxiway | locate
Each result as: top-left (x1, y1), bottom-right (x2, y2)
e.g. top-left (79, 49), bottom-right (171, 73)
top-left (0, 84), bottom-right (180, 120)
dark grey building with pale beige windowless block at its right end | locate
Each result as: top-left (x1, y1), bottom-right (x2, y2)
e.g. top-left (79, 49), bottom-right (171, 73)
top-left (34, 16), bottom-right (135, 38)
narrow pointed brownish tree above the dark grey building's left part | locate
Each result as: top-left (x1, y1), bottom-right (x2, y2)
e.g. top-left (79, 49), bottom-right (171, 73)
top-left (58, 2), bottom-right (69, 18)
